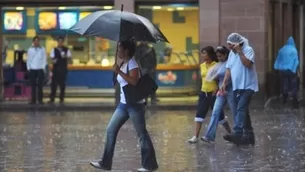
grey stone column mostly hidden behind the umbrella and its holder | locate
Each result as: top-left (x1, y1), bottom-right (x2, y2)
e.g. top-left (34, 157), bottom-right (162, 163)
top-left (114, 0), bottom-right (135, 105)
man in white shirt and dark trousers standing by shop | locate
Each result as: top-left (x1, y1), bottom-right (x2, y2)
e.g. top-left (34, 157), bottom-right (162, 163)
top-left (27, 36), bottom-right (47, 104)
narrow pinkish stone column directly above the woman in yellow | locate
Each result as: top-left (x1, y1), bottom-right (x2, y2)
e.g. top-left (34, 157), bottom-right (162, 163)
top-left (199, 0), bottom-right (220, 62)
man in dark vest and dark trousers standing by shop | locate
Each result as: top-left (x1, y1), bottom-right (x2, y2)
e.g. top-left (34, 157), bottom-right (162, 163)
top-left (49, 37), bottom-right (72, 103)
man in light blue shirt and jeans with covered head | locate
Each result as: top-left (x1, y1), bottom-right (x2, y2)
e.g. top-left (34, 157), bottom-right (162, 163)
top-left (221, 33), bottom-right (258, 145)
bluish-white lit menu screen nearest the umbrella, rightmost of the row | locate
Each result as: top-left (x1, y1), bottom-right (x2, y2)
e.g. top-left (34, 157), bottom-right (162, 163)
top-left (59, 12), bottom-right (77, 30)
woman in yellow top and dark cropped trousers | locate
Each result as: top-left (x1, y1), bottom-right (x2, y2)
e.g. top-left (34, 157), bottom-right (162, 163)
top-left (188, 46), bottom-right (230, 143)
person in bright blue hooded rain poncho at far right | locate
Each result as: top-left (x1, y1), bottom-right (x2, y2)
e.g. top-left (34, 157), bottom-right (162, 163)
top-left (274, 36), bottom-right (299, 108)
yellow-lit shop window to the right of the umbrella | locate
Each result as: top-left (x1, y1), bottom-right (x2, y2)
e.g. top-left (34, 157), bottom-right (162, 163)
top-left (136, 4), bottom-right (199, 65)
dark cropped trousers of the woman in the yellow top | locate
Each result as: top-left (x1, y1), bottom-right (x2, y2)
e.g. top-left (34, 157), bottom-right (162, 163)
top-left (195, 91), bottom-right (225, 122)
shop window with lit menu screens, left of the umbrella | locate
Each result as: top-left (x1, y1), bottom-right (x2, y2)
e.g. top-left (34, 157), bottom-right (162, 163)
top-left (2, 6), bottom-right (116, 66)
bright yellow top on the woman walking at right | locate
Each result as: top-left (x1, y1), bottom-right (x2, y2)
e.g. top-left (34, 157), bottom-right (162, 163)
top-left (200, 62), bottom-right (218, 92)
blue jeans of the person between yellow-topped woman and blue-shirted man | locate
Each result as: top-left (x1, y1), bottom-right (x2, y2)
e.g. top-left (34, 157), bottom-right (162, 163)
top-left (205, 88), bottom-right (236, 141)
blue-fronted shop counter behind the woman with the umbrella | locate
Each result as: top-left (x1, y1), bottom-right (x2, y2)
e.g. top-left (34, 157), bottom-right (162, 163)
top-left (48, 65), bottom-right (198, 94)
